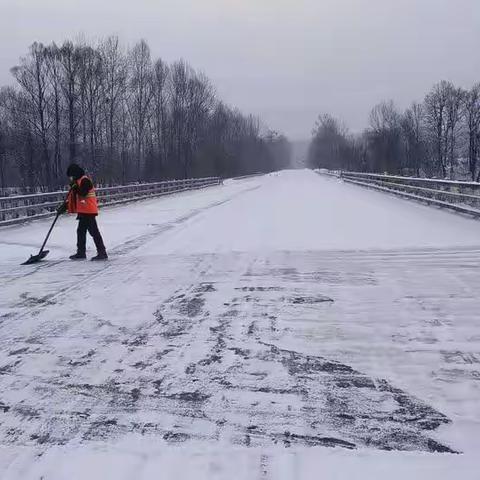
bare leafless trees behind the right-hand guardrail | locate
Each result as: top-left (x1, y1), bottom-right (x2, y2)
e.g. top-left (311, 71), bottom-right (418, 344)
top-left (308, 81), bottom-right (480, 181)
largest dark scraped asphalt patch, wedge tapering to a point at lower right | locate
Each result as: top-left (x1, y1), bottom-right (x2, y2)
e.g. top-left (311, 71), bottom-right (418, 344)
top-left (260, 345), bottom-right (457, 453)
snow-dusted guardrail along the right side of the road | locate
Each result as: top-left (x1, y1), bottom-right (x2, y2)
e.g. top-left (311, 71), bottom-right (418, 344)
top-left (318, 172), bottom-right (480, 218)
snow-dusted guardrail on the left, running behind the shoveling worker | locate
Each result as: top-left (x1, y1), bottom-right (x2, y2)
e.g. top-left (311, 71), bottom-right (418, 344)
top-left (0, 177), bottom-right (222, 227)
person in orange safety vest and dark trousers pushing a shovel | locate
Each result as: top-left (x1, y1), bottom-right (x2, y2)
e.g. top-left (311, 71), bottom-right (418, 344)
top-left (58, 163), bottom-right (108, 260)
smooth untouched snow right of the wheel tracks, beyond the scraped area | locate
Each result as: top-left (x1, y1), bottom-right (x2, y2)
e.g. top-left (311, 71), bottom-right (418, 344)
top-left (154, 171), bottom-right (480, 253)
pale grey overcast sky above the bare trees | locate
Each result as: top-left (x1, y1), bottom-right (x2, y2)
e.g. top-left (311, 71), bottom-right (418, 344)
top-left (0, 0), bottom-right (480, 139)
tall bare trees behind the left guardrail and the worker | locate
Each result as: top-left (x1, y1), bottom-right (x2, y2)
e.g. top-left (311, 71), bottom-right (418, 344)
top-left (0, 37), bottom-right (290, 188)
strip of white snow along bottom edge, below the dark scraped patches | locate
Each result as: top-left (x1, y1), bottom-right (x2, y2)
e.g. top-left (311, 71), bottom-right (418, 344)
top-left (2, 438), bottom-right (478, 480)
